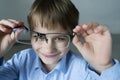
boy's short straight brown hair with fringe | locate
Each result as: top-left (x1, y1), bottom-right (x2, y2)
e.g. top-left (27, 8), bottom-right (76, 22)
top-left (28, 0), bottom-right (79, 32)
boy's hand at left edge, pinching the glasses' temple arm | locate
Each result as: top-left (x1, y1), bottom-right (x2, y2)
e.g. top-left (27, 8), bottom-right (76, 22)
top-left (0, 19), bottom-right (24, 58)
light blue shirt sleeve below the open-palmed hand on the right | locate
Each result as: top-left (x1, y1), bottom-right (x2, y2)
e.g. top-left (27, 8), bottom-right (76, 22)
top-left (88, 59), bottom-right (120, 80)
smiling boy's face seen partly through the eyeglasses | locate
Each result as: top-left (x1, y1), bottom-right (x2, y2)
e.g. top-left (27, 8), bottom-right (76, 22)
top-left (31, 26), bottom-right (70, 65)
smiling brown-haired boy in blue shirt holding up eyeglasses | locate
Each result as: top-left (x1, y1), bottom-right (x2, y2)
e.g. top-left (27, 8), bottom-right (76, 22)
top-left (0, 0), bottom-right (120, 80)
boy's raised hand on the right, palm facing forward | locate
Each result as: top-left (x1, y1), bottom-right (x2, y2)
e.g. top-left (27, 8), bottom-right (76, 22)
top-left (73, 23), bottom-right (113, 73)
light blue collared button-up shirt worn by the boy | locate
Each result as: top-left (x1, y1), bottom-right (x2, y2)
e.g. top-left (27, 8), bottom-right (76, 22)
top-left (0, 48), bottom-right (120, 80)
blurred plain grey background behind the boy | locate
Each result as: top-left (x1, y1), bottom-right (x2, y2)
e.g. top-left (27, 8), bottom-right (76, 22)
top-left (0, 0), bottom-right (120, 60)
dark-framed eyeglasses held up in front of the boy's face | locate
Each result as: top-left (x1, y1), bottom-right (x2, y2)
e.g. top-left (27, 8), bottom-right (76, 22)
top-left (14, 28), bottom-right (73, 48)
